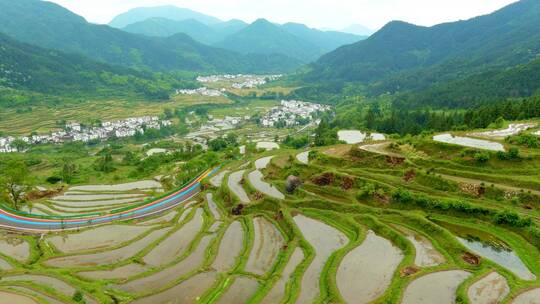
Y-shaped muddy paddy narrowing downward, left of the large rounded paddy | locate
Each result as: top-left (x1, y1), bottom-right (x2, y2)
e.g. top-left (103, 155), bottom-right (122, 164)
top-left (294, 215), bottom-right (349, 303)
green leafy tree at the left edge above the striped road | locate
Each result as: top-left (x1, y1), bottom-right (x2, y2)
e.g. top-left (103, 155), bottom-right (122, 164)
top-left (0, 160), bottom-right (32, 210)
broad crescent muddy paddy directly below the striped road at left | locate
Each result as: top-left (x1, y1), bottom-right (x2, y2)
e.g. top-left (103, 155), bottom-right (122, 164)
top-left (48, 225), bottom-right (150, 253)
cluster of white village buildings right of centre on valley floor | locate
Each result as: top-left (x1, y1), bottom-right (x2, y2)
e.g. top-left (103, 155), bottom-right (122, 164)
top-left (260, 100), bottom-right (330, 127)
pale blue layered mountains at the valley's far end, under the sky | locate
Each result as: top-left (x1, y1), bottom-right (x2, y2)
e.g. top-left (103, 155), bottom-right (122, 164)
top-left (117, 8), bottom-right (366, 63)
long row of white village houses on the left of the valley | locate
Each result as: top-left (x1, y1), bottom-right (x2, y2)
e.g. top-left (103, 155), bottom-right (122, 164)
top-left (0, 116), bottom-right (172, 153)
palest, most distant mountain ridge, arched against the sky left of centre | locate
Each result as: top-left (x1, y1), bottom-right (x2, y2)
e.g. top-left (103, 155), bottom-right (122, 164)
top-left (109, 5), bottom-right (222, 28)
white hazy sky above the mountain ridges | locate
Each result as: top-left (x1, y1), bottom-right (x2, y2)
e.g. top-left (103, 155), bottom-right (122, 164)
top-left (46, 0), bottom-right (516, 29)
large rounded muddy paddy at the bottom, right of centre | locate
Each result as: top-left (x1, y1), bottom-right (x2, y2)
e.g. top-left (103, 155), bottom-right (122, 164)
top-left (337, 231), bottom-right (403, 303)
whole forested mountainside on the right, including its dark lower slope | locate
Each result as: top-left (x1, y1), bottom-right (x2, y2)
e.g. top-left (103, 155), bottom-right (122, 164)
top-left (303, 0), bottom-right (540, 107)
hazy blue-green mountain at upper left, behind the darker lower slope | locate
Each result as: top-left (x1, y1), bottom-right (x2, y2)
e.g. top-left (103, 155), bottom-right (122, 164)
top-left (0, 0), bottom-right (299, 73)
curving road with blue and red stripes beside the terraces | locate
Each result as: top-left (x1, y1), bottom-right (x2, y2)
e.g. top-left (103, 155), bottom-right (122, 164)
top-left (0, 168), bottom-right (219, 233)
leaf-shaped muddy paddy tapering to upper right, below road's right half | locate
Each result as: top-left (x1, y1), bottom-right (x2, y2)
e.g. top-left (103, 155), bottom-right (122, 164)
top-left (143, 208), bottom-right (204, 266)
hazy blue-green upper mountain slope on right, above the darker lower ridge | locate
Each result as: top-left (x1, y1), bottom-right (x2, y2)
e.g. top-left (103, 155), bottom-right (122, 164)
top-left (305, 0), bottom-right (540, 98)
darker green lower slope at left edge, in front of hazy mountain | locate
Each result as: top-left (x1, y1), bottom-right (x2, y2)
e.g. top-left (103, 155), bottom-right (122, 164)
top-left (0, 34), bottom-right (188, 99)
